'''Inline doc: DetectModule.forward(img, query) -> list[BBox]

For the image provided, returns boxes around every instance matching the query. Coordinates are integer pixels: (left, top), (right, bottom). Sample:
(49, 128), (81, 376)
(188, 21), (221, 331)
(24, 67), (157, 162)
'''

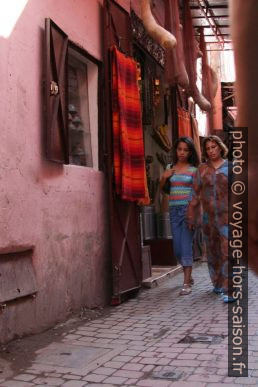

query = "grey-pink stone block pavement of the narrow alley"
(0, 263), (258, 387)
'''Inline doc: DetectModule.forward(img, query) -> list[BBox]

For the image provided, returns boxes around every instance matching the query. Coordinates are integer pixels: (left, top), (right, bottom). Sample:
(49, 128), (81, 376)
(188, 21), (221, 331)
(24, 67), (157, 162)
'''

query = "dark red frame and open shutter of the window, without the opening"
(43, 18), (105, 170)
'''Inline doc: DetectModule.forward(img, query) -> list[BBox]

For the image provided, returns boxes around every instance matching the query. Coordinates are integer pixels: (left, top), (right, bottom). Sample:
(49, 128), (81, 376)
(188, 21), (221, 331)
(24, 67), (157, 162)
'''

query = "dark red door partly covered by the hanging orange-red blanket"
(103, 0), (142, 305)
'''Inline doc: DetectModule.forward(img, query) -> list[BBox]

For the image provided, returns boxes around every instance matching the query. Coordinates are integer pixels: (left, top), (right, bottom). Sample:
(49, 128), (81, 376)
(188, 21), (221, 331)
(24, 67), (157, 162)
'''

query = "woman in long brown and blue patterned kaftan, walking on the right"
(187, 136), (234, 302)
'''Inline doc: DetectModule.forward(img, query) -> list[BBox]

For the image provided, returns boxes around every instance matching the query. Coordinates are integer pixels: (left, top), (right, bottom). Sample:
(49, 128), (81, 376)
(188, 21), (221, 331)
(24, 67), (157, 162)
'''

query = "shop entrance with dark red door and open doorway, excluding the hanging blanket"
(103, 0), (179, 304)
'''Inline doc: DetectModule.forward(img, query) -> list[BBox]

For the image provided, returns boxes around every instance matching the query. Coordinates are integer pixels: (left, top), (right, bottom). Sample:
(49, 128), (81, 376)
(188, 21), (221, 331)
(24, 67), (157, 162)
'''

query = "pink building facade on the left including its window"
(0, 0), (111, 342)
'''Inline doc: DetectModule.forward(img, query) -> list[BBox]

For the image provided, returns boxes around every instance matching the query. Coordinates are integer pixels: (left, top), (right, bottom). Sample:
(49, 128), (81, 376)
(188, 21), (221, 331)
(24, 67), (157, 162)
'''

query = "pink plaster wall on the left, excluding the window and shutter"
(0, 0), (111, 342)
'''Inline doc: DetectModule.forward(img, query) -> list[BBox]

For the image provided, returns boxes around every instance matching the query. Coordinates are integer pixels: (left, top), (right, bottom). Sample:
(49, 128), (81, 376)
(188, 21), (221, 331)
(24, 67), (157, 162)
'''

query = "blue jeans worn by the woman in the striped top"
(169, 205), (194, 266)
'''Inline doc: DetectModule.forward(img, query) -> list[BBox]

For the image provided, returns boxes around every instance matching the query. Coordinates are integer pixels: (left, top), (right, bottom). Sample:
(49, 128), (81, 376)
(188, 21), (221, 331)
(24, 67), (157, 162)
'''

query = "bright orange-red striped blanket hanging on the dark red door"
(111, 46), (150, 204)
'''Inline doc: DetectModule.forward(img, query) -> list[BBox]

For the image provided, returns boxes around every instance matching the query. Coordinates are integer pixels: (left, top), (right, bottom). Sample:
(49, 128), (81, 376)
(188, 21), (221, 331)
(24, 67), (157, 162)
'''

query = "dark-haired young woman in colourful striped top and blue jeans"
(160, 137), (199, 295)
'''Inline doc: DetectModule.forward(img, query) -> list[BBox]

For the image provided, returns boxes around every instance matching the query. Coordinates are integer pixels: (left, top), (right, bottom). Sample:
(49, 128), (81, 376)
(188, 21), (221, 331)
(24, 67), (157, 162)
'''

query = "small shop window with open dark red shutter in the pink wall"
(45, 19), (99, 167)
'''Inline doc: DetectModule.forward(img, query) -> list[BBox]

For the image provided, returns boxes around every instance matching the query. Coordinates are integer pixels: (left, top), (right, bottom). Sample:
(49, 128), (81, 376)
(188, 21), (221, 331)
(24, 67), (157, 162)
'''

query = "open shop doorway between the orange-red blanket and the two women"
(131, 31), (177, 281)
